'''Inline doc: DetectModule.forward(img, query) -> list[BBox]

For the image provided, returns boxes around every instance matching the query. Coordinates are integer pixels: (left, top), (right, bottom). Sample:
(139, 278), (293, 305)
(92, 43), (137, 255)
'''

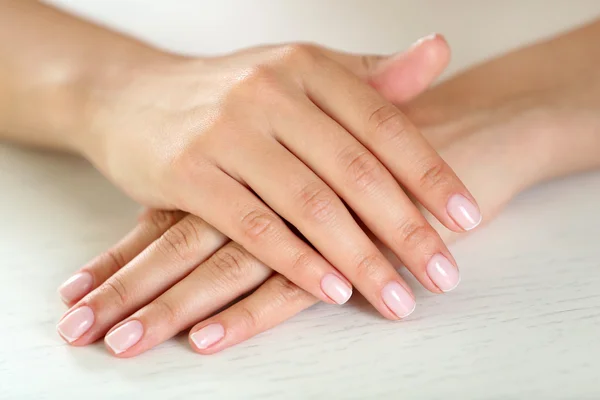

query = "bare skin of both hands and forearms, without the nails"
(0, 1), (598, 357)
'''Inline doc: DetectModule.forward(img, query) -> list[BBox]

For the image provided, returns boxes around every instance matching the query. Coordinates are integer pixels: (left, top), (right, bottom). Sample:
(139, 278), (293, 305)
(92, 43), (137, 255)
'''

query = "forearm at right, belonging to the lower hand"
(411, 21), (600, 185)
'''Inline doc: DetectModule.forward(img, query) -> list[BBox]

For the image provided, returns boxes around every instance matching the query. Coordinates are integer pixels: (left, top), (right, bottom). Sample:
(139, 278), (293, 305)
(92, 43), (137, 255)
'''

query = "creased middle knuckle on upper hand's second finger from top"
(342, 150), (384, 189)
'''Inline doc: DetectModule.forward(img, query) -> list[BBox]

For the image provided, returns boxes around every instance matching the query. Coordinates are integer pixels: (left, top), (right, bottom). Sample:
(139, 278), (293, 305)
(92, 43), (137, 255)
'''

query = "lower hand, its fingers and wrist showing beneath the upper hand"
(58, 87), (536, 357)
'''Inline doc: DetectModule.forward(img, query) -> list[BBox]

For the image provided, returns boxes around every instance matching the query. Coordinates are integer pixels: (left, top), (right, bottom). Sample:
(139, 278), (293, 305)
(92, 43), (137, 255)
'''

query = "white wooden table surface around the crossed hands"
(0, 0), (600, 400)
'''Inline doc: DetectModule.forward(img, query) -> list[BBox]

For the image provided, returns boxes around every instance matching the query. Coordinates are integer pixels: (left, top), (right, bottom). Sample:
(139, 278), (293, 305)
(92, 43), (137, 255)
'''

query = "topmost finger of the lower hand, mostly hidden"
(58, 210), (185, 307)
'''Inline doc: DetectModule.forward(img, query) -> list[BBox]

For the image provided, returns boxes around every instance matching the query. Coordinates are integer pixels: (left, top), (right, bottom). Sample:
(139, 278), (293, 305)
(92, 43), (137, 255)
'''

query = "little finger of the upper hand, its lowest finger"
(171, 162), (352, 304)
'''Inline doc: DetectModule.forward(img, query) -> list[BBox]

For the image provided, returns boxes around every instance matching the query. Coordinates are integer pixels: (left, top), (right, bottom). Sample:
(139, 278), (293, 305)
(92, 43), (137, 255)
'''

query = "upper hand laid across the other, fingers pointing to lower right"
(74, 37), (481, 319)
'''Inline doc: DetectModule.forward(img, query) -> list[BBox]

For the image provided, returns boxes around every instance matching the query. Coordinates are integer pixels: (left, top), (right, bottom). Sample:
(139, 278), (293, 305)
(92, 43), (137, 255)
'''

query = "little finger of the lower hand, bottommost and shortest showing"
(189, 274), (318, 354)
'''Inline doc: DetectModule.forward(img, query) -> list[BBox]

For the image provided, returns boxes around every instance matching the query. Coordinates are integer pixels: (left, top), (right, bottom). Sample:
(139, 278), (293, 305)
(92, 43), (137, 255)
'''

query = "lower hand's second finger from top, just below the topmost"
(57, 215), (228, 346)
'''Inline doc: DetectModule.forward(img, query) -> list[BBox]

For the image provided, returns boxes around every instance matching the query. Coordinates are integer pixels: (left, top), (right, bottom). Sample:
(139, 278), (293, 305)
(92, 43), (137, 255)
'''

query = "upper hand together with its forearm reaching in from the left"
(0, 1), (481, 319)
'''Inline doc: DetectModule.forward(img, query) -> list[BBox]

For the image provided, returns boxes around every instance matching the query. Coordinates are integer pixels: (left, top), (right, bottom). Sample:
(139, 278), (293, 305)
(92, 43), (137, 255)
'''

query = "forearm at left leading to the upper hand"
(0, 0), (164, 150)
